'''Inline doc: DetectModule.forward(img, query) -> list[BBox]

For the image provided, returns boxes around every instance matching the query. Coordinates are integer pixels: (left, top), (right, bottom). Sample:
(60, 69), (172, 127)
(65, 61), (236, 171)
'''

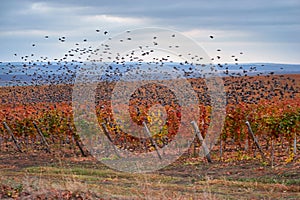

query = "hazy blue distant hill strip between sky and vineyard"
(0, 62), (300, 86)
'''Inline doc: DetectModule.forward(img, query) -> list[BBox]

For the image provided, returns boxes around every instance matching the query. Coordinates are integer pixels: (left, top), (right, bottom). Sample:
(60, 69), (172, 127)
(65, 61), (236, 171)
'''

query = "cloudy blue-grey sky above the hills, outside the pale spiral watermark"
(0, 0), (300, 64)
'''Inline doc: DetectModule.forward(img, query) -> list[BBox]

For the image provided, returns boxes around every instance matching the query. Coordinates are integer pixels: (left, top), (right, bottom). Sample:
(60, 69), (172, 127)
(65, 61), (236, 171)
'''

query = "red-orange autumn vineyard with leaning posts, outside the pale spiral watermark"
(0, 75), (300, 199)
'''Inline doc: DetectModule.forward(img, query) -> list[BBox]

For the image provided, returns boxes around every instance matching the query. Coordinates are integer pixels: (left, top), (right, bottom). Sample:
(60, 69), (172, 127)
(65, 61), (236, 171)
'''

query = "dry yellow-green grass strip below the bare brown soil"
(0, 160), (300, 199)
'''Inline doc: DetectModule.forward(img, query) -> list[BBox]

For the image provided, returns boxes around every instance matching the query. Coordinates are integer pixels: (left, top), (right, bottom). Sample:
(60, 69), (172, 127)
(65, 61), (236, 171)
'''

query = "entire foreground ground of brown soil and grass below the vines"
(0, 152), (300, 199)
